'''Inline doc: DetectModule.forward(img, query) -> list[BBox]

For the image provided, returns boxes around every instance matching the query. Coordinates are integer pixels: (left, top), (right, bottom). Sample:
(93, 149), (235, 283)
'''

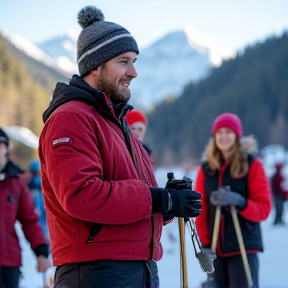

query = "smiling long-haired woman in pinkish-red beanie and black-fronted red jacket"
(195, 113), (271, 288)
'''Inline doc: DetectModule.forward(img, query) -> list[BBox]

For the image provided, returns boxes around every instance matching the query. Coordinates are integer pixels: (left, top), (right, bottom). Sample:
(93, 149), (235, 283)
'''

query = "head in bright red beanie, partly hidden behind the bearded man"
(125, 110), (147, 143)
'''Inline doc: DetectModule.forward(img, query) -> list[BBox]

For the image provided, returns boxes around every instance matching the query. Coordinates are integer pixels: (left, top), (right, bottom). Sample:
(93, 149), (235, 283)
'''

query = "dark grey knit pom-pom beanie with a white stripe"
(77, 6), (139, 77)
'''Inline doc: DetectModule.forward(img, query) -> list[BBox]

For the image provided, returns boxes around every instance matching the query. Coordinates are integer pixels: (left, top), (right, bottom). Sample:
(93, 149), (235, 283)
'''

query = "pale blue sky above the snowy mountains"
(0, 0), (288, 49)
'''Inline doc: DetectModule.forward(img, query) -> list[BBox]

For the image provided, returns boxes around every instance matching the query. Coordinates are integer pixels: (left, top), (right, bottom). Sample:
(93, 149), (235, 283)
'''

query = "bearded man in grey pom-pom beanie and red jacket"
(39, 6), (201, 288)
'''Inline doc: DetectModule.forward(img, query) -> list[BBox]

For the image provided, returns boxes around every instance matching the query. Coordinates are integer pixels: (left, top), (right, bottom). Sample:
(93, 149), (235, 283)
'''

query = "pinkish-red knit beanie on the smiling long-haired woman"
(212, 113), (242, 138)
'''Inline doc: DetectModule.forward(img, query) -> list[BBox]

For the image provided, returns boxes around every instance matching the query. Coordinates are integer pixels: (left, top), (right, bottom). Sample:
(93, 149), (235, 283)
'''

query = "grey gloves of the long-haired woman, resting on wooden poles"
(209, 189), (247, 209)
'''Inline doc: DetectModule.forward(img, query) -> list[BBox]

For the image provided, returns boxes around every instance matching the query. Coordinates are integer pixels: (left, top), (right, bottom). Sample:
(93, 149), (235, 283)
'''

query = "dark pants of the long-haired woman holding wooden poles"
(213, 254), (259, 288)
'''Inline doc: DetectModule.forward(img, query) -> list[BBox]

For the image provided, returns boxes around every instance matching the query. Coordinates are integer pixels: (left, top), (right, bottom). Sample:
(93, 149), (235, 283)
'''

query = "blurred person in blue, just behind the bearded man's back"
(28, 159), (49, 240)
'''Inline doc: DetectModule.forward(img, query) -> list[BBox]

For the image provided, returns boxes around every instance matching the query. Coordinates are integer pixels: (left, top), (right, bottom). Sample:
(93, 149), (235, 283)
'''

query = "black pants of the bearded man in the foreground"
(54, 260), (159, 288)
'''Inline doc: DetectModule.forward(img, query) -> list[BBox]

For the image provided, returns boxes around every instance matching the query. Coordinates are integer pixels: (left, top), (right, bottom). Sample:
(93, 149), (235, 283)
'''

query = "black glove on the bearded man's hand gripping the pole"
(150, 185), (202, 218)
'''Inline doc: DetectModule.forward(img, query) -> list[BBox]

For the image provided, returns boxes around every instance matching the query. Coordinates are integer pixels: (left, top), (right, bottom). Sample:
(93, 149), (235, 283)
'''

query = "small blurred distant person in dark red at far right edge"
(271, 162), (288, 225)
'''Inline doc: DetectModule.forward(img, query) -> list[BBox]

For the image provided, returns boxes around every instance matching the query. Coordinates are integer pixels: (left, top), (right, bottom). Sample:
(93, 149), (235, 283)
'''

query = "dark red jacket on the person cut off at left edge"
(0, 161), (48, 267)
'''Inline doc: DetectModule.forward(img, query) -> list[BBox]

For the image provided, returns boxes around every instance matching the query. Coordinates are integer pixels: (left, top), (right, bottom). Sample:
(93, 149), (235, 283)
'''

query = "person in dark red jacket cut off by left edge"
(0, 128), (50, 288)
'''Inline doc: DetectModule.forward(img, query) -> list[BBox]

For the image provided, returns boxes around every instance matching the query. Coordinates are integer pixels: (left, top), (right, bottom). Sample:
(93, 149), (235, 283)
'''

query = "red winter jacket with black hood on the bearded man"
(39, 75), (163, 265)
